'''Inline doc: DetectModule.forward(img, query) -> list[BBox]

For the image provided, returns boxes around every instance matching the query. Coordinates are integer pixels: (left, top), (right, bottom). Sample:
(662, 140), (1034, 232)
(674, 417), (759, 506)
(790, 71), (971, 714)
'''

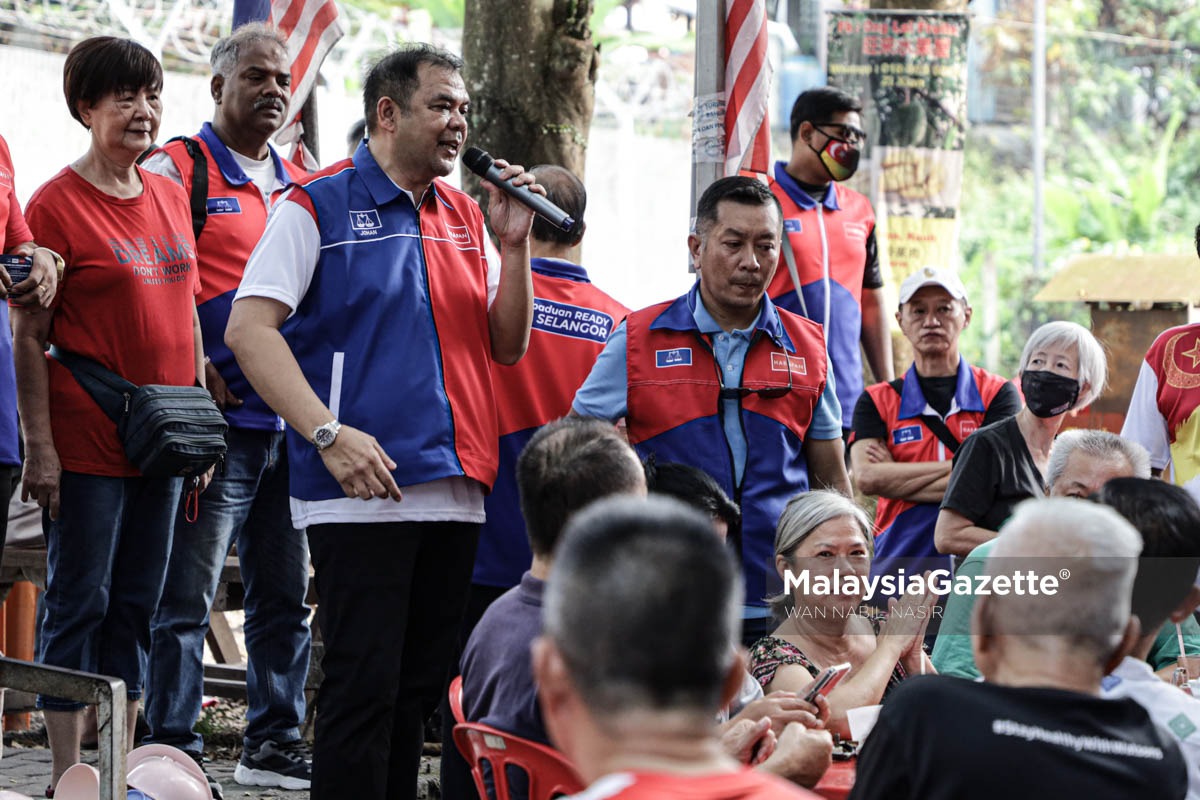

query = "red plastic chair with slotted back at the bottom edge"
(454, 722), (584, 800)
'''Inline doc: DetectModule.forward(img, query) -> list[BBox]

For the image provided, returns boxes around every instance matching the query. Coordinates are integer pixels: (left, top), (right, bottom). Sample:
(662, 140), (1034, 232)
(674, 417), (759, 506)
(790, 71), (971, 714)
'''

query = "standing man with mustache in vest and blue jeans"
(143, 23), (311, 800)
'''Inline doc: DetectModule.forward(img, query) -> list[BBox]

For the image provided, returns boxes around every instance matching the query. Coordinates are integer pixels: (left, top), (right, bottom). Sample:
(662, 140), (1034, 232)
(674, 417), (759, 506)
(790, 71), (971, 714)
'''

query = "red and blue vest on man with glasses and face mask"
(767, 162), (875, 428)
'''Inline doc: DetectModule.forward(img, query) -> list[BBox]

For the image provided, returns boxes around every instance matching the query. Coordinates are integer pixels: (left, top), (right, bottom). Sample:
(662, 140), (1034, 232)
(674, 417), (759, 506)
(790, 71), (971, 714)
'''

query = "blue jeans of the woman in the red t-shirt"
(37, 471), (184, 711)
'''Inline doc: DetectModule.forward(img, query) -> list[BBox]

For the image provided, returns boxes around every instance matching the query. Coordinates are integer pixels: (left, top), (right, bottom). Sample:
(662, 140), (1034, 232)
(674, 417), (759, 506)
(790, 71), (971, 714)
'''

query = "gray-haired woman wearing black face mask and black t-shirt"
(934, 321), (1108, 558)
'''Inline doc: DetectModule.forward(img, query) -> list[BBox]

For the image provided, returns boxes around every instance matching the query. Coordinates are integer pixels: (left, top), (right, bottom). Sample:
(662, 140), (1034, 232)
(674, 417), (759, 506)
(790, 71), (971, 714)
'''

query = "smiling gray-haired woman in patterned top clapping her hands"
(750, 492), (935, 736)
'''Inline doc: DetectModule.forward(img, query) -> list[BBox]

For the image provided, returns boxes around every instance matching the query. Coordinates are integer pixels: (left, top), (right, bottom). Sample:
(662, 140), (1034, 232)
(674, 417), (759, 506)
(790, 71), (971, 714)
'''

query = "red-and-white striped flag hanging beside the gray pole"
(725, 0), (772, 175)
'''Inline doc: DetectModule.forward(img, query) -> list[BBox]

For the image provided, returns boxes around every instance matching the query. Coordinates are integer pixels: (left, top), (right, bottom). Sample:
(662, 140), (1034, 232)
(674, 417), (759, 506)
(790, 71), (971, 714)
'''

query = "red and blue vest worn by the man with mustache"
(162, 122), (305, 431)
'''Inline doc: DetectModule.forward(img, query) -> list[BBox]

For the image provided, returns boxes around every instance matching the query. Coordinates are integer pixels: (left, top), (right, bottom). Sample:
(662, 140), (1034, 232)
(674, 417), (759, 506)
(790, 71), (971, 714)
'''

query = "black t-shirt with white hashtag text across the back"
(850, 675), (1188, 800)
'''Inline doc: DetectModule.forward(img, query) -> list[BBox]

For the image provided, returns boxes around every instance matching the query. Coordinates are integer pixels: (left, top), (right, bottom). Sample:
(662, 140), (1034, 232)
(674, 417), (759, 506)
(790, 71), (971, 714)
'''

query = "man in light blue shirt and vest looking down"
(571, 178), (850, 638)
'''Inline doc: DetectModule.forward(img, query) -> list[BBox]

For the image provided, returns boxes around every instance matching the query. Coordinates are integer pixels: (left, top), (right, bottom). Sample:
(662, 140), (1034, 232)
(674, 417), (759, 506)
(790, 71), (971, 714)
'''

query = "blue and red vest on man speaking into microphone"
(280, 144), (497, 500)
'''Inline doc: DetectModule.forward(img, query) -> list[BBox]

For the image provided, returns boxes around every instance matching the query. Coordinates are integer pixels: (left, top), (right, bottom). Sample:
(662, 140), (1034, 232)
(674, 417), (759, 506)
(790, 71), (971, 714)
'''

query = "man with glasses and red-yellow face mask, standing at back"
(768, 86), (894, 437)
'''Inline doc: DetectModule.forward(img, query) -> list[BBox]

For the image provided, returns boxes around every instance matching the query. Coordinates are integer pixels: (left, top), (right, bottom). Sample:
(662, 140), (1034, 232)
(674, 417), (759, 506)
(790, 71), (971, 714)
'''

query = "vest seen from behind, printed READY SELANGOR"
(472, 258), (629, 587)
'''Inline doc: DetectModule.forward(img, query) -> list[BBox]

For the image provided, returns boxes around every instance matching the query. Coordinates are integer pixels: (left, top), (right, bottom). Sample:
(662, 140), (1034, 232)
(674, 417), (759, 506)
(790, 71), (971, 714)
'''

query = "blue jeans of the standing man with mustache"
(145, 428), (311, 752)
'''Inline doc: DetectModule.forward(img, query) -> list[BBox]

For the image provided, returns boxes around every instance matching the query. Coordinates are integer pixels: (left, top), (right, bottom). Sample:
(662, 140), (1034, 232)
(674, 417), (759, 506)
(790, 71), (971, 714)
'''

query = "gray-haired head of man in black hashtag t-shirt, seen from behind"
(974, 498), (1141, 663)
